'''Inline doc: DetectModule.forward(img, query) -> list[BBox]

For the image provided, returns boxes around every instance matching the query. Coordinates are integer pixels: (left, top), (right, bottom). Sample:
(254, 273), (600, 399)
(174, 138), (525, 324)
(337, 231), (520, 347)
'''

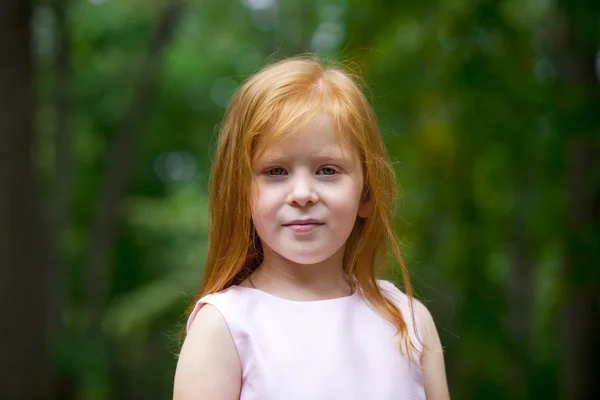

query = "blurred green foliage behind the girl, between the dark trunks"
(34, 0), (600, 399)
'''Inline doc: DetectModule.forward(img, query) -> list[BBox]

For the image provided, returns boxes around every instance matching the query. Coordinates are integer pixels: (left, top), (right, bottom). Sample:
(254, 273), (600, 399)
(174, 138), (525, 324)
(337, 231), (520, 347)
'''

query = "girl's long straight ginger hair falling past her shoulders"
(189, 57), (417, 355)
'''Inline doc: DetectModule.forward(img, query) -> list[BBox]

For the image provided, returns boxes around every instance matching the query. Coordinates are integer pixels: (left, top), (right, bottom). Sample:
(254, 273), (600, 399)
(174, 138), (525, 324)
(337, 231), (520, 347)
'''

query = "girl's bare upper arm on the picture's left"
(173, 304), (241, 400)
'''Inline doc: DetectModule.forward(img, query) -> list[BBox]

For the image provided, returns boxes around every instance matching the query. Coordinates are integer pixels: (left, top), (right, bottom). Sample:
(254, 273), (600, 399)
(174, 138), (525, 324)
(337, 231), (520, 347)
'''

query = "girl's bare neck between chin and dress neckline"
(251, 246), (352, 300)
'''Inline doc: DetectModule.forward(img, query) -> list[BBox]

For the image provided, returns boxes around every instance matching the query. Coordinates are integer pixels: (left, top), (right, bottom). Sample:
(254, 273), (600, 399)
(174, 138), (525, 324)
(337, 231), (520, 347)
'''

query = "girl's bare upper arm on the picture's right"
(414, 300), (450, 400)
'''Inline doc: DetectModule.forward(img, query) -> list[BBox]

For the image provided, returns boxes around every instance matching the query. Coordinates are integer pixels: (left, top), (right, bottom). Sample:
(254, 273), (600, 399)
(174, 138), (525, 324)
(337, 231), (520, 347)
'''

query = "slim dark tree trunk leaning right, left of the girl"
(84, 0), (183, 337)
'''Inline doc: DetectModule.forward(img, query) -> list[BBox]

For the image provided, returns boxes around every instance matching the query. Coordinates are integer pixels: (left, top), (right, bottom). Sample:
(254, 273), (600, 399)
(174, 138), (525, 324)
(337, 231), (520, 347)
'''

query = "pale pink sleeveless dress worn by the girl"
(187, 280), (425, 400)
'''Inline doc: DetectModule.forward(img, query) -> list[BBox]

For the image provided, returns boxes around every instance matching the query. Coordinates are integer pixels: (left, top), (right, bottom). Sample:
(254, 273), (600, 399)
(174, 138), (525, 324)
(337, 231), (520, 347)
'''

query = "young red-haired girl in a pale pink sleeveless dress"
(174, 54), (448, 400)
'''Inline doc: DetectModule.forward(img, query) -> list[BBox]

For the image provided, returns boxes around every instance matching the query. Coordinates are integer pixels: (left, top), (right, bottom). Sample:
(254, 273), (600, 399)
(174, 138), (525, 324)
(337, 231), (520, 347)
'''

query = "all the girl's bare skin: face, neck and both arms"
(174, 114), (449, 400)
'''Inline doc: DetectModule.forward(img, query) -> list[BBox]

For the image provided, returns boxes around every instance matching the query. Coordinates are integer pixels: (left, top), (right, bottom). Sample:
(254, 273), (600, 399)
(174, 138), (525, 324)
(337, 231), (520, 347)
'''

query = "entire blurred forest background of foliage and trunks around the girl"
(0, 0), (600, 400)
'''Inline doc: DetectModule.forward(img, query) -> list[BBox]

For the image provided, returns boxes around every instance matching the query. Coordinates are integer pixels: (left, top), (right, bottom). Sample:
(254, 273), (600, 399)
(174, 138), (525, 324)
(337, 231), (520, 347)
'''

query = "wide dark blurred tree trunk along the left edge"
(0, 0), (52, 399)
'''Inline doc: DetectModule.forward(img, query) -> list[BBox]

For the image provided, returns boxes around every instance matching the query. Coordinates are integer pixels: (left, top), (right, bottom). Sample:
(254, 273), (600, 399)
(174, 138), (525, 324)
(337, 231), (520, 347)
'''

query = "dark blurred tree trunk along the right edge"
(556, 1), (600, 400)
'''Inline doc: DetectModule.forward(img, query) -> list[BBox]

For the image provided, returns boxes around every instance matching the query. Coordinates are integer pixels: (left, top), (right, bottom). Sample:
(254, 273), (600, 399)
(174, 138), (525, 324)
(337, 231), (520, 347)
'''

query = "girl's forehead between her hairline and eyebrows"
(253, 114), (355, 161)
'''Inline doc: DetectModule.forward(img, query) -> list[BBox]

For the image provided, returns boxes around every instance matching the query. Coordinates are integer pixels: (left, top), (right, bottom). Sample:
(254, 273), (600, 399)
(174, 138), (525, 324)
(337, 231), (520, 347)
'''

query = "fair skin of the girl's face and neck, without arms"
(246, 114), (368, 300)
